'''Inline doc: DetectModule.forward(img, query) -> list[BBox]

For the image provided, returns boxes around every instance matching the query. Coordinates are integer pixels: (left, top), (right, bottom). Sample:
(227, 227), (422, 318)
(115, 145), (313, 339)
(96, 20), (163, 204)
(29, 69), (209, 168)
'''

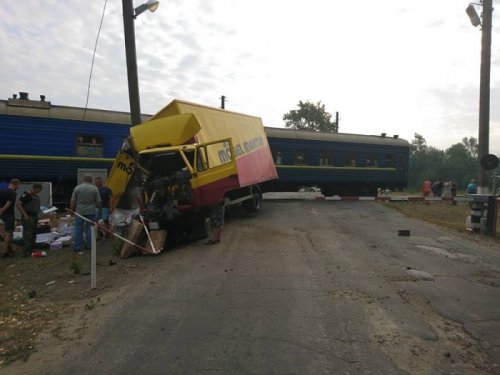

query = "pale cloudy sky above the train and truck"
(0, 0), (500, 156)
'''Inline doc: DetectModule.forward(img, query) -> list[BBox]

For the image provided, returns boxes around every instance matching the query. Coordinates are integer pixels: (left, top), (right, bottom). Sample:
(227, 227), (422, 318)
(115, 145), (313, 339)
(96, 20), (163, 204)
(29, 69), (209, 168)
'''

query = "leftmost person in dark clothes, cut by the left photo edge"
(0, 178), (21, 258)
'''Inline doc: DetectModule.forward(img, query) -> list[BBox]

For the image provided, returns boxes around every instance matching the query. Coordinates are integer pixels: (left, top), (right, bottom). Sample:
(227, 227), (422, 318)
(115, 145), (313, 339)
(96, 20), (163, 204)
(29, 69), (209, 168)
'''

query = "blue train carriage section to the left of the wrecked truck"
(0, 98), (139, 202)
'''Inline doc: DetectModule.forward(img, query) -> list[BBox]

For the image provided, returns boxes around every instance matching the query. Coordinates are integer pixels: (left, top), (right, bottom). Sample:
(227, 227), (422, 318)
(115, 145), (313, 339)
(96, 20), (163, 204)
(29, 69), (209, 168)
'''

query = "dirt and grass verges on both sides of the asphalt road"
(0, 202), (500, 367)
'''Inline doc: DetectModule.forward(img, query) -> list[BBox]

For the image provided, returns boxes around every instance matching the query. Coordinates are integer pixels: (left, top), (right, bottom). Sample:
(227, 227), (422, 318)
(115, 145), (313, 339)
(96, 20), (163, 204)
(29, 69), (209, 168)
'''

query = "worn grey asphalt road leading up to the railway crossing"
(11, 201), (500, 374)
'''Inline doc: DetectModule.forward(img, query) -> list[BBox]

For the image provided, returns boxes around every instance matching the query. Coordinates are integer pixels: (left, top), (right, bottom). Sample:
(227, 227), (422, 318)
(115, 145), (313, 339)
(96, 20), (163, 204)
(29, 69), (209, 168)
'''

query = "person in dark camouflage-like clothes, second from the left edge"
(16, 184), (42, 257)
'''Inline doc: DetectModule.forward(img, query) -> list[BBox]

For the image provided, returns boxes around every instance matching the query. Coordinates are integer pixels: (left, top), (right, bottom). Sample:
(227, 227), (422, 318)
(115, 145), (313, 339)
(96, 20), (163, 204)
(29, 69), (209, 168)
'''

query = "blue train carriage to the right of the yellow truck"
(266, 128), (409, 195)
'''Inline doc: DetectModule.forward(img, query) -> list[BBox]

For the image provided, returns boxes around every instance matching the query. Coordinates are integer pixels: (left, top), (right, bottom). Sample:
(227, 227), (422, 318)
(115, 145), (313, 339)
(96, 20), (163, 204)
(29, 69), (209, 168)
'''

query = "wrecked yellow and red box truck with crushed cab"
(108, 100), (277, 244)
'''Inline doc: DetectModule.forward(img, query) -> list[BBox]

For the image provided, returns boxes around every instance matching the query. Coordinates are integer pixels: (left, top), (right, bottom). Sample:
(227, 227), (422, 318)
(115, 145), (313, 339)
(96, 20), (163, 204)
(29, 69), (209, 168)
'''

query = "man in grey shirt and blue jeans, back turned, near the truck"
(69, 174), (102, 253)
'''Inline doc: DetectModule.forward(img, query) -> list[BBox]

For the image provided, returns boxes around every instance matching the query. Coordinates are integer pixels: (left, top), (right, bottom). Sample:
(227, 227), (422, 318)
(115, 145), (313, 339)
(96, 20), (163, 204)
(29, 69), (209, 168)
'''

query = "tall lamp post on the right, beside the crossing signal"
(466, 0), (493, 189)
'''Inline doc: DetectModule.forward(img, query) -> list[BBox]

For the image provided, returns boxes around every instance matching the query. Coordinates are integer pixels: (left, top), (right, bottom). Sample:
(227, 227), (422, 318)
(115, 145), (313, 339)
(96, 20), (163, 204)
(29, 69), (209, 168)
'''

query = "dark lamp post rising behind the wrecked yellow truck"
(122, 0), (160, 125)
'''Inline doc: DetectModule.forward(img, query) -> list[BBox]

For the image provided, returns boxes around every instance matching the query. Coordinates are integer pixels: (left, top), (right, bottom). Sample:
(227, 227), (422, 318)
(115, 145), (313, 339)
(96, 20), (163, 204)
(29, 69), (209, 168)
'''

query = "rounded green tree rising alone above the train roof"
(283, 101), (339, 133)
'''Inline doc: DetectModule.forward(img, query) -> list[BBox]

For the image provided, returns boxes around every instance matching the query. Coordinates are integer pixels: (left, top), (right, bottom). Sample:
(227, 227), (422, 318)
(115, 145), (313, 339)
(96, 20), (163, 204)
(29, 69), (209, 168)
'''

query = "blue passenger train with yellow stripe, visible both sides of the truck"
(0, 97), (409, 204)
